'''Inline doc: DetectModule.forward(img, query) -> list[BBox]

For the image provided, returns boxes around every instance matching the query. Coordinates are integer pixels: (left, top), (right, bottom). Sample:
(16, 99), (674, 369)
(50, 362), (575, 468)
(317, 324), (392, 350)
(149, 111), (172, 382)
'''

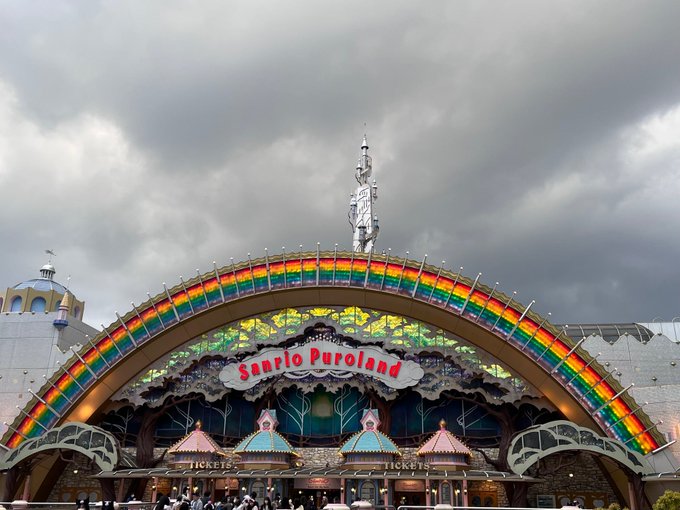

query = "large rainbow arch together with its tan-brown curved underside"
(3, 251), (663, 454)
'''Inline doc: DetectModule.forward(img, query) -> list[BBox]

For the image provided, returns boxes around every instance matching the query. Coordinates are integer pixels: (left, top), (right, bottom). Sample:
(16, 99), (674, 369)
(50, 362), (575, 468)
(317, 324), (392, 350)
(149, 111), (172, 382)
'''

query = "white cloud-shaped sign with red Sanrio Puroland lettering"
(219, 340), (424, 390)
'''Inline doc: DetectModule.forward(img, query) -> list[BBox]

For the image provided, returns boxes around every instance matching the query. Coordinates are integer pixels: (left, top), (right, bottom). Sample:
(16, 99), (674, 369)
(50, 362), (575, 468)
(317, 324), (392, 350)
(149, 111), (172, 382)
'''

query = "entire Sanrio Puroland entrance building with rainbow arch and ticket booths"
(0, 143), (680, 509)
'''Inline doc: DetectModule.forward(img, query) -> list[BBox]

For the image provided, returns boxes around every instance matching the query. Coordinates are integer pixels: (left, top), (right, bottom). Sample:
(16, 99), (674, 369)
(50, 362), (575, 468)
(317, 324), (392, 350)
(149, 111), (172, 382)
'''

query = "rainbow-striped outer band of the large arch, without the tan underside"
(3, 251), (663, 454)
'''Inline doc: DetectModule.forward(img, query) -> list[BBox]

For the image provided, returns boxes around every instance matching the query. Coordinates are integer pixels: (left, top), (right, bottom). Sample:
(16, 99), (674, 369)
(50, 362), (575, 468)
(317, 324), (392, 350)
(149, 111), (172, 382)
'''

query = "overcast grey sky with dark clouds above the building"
(0, 0), (680, 327)
